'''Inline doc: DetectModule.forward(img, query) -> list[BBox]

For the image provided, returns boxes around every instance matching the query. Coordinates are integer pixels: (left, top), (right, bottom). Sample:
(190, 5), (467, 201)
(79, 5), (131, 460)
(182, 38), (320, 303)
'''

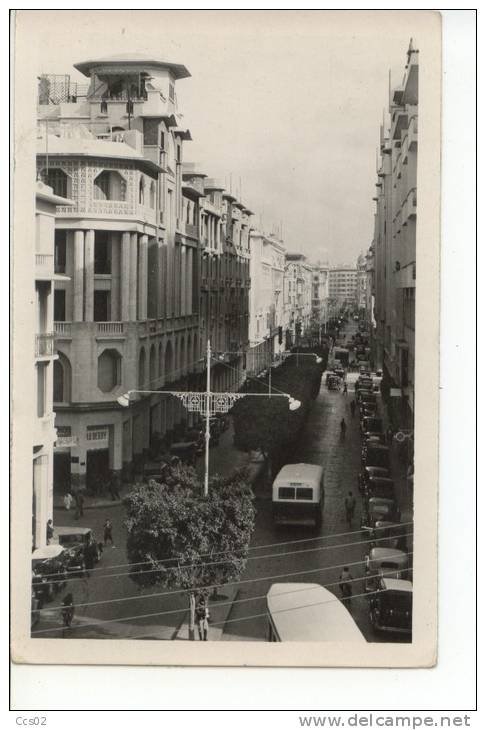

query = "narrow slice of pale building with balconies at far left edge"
(32, 181), (70, 549)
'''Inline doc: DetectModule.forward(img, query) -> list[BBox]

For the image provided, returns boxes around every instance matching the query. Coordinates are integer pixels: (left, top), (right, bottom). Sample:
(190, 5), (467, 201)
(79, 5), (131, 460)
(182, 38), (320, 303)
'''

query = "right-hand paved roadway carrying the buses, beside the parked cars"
(223, 323), (412, 641)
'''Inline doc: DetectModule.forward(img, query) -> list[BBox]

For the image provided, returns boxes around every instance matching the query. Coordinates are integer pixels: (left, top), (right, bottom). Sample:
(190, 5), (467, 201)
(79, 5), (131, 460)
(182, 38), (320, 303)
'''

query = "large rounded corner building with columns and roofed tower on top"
(38, 55), (204, 489)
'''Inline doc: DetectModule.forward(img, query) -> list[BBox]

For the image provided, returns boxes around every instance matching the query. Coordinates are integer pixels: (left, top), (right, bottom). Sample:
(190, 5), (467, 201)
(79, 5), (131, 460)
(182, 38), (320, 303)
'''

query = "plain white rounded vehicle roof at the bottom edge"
(267, 583), (366, 644)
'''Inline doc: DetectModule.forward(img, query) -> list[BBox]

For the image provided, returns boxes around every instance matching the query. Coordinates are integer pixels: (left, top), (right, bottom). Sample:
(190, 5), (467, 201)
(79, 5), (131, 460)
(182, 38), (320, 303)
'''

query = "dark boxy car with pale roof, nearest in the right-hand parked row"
(370, 578), (413, 634)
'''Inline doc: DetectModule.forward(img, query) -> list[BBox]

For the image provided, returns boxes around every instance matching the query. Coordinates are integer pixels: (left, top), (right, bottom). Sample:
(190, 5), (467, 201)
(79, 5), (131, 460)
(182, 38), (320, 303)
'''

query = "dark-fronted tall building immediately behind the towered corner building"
(196, 173), (252, 391)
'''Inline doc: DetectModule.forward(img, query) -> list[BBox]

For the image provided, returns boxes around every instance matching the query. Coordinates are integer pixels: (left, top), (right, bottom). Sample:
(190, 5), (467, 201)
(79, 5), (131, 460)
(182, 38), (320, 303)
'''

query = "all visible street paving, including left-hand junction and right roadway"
(34, 323), (411, 641)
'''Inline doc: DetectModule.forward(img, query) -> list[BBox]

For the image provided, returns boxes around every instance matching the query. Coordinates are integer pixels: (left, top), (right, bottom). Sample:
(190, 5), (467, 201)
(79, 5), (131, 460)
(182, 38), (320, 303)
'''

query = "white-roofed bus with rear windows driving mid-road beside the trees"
(272, 464), (324, 528)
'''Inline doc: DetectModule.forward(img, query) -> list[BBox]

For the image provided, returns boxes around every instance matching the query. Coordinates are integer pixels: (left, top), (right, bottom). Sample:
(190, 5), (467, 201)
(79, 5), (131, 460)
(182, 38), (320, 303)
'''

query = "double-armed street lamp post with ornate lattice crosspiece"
(117, 340), (301, 497)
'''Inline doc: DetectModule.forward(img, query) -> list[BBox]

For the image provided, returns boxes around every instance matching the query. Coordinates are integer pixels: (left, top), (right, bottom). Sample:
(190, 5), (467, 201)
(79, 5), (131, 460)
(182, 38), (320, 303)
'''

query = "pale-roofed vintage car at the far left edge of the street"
(32, 544), (69, 608)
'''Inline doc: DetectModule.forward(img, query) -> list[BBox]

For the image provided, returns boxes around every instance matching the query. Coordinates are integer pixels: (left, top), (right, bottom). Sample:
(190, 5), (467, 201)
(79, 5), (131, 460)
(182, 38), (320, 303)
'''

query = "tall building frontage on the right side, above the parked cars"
(373, 42), (419, 426)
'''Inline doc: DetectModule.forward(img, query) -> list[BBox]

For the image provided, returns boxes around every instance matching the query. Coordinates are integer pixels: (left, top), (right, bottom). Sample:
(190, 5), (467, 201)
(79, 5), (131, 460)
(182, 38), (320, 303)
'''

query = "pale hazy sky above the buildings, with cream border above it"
(24, 10), (428, 263)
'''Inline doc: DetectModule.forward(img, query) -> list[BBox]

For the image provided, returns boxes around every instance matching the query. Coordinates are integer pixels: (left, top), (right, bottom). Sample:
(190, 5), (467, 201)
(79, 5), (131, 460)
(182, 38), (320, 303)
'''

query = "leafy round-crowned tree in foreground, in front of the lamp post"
(124, 466), (255, 639)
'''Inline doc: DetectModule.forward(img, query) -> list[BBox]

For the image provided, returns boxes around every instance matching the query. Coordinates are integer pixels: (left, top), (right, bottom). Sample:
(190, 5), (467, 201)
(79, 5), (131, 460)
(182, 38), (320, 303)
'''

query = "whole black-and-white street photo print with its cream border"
(12, 10), (440, 666)
